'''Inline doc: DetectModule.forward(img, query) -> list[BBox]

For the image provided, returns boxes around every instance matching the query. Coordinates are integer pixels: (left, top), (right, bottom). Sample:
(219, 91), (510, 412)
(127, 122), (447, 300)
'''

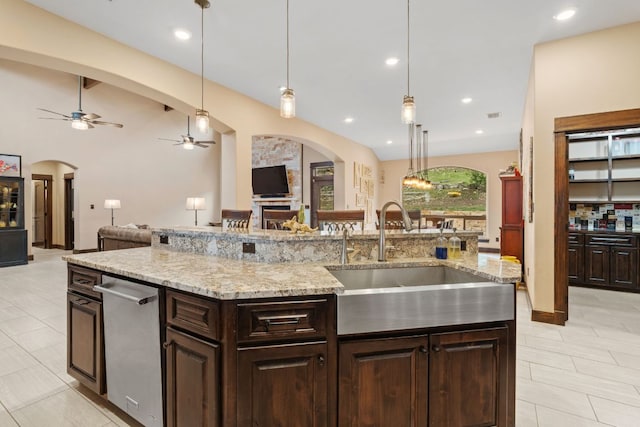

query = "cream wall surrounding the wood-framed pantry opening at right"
(526, 22), (640, 312)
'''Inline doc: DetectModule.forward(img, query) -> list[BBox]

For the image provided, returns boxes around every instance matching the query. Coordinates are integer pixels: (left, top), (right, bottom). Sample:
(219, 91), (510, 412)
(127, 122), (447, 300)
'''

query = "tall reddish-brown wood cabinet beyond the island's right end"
(500, 176), (524, 263)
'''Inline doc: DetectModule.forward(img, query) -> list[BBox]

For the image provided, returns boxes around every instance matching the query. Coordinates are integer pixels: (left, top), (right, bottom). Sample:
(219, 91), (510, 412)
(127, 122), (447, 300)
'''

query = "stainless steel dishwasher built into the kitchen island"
(94, 275), (163, 427)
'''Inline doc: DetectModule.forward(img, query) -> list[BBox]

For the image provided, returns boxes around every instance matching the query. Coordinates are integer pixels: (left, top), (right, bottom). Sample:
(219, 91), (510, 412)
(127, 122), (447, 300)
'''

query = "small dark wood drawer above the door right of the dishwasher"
(167, 290), (220, 340)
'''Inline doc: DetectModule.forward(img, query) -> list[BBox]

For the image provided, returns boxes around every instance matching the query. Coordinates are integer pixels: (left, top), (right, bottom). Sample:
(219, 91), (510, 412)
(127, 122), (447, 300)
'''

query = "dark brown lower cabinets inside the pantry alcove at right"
(568, 233), (640, 291)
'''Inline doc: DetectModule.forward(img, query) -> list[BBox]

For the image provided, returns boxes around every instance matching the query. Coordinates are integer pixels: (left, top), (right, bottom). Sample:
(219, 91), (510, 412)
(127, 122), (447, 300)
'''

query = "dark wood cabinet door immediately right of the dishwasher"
(164, 328), (220, 427)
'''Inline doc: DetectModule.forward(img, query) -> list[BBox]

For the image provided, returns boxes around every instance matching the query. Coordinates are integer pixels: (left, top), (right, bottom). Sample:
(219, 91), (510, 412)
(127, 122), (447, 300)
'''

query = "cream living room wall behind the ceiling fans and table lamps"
(0, 60), (220, 250)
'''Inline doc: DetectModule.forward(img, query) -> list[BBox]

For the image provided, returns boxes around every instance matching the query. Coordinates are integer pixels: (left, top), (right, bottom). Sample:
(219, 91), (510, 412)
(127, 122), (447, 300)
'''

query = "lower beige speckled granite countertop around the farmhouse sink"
(62, 247), (521, 300)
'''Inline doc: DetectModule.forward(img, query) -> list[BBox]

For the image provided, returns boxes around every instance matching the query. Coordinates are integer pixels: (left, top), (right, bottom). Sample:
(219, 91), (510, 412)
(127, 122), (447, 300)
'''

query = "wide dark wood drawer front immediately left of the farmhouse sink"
(238, 299), (329, 343)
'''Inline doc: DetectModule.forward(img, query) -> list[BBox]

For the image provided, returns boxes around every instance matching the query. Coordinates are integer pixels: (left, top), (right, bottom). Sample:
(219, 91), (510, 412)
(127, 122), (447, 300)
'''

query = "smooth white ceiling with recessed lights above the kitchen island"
(26, 0), (640, 160)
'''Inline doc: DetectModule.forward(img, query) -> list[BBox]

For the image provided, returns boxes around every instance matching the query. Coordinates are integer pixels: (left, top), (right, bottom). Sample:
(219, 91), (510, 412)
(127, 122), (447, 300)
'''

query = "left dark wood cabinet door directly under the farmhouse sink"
(338, 336), (429, 427)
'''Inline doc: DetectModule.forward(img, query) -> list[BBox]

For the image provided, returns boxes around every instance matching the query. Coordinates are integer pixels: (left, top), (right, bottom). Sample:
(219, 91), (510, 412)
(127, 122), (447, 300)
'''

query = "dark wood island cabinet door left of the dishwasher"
(67, 292), (106, 394)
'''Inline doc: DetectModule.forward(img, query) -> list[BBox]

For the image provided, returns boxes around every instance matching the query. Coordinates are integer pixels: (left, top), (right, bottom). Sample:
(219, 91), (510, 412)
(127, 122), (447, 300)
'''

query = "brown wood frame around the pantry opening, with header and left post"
(552, 108), (640, 325)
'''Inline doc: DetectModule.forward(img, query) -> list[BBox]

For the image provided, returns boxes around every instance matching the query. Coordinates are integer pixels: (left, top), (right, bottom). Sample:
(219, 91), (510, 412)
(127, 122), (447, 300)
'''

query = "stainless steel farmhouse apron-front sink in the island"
(329, 266), (515, 335)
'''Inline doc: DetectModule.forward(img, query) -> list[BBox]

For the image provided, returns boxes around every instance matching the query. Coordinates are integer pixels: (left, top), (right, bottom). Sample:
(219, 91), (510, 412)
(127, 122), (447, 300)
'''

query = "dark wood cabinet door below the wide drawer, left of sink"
(237, 341), (329, 427)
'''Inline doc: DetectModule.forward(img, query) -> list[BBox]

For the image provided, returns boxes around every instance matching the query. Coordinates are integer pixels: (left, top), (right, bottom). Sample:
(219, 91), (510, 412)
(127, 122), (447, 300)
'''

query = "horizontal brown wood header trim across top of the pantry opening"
(554, 108), (640, 133)
